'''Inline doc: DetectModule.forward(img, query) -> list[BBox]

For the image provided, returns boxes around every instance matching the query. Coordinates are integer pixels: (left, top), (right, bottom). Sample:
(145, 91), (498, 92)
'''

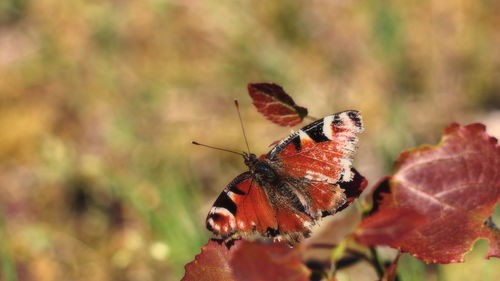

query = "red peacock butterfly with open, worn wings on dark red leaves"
(206, 110), (366, 245)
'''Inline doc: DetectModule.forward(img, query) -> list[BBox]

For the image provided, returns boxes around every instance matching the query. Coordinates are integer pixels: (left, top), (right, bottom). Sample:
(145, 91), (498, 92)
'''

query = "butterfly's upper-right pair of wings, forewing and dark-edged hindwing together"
(261, 110), (366, 219)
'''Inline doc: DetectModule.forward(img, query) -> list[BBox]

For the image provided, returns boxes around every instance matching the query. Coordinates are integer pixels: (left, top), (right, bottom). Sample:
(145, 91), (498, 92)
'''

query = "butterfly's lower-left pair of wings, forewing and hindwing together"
(207, 172), (314, 243)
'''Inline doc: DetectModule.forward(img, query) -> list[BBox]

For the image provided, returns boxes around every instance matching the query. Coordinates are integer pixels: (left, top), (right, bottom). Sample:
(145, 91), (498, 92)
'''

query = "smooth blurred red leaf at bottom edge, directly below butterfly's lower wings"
(231, 241), (311, 281)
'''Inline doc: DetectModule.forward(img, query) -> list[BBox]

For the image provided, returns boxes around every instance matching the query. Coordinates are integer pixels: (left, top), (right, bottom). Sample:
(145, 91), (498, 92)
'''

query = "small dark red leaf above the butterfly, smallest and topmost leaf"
(247, 83), (307, 126)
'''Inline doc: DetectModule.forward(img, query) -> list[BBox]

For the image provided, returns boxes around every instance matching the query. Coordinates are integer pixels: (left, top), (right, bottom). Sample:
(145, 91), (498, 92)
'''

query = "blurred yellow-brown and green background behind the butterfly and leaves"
(0, 0), (500, 281)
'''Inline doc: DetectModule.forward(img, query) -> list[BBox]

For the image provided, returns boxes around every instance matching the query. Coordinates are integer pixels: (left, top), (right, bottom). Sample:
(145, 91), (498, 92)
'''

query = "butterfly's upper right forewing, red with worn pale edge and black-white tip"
(266, 110), (363, 184)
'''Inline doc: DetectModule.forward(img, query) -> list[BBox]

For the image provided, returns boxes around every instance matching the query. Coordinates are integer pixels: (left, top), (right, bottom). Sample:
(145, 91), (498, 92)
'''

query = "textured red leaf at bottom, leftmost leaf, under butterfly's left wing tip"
(181, 240), (240, 281)
